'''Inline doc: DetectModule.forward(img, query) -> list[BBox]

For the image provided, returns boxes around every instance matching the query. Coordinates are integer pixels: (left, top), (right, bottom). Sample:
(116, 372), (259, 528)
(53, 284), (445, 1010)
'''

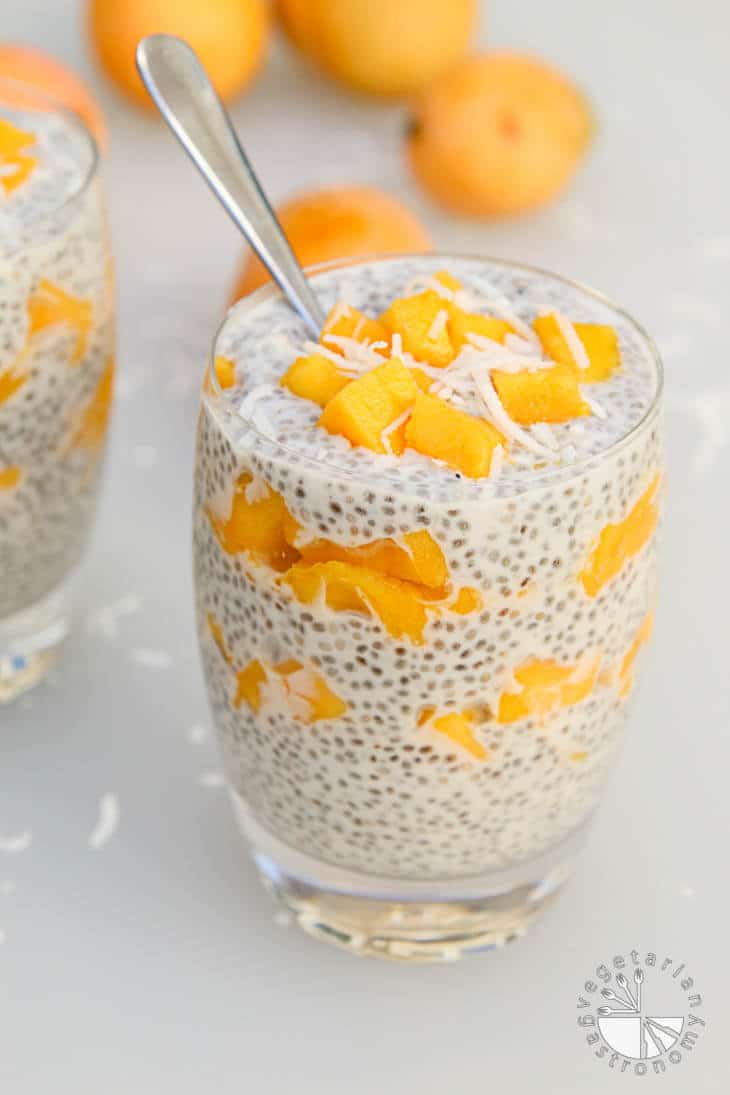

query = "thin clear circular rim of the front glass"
(201, 250), (664, 498)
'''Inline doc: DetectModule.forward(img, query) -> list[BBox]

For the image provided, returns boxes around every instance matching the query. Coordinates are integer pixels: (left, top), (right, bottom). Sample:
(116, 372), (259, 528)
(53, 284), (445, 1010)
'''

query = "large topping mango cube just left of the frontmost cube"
(318, 358), (418, 452)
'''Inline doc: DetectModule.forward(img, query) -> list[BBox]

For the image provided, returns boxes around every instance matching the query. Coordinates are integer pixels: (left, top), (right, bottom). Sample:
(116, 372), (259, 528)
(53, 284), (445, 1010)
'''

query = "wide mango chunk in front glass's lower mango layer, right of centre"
(497, 657), (601, 723)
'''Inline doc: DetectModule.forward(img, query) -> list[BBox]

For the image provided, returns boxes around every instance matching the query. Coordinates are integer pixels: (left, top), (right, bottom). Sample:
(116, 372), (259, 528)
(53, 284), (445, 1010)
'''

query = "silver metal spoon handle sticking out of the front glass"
(137, 34), (324, 338)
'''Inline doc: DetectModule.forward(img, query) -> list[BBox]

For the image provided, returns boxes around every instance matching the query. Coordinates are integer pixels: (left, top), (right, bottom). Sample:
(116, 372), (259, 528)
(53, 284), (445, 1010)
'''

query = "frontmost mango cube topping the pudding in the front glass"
(405, 392), (502, 479)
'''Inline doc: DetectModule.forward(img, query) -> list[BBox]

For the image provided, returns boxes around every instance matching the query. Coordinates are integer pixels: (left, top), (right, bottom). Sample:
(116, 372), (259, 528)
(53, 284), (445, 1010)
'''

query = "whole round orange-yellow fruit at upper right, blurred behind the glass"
(407, 54), (592, 218)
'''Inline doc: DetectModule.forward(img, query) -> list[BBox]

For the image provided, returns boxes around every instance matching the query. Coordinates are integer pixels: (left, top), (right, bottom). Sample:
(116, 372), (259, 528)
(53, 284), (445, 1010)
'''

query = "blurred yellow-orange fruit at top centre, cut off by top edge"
(278, 0), (477, 96)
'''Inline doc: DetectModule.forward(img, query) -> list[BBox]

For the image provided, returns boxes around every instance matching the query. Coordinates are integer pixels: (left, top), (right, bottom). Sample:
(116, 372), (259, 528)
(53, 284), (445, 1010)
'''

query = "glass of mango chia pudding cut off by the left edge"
(0, 80), (115, 701)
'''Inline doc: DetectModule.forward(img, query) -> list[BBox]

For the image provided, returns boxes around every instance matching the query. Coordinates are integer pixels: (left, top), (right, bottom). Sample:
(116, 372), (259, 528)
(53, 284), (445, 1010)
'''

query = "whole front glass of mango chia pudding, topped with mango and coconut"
(194, 255), (662, 959)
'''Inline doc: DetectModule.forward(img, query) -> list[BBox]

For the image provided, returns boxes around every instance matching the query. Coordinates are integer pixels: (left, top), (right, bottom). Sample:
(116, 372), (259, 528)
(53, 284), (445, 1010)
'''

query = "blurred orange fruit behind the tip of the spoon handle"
(89, 0), (270, 110)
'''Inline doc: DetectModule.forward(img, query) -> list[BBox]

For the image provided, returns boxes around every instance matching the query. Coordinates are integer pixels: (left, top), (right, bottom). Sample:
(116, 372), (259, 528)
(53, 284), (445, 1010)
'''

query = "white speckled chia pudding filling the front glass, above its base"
(194, 255), (662, 880)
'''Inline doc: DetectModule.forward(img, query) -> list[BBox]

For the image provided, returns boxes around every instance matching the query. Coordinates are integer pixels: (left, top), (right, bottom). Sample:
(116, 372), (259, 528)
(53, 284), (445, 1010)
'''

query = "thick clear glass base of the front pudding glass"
(231, 791), (587, 961)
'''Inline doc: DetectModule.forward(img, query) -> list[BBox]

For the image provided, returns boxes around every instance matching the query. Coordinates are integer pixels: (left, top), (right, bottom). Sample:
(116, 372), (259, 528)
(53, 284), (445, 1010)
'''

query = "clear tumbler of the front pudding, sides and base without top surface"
(194, 255), (662, 960)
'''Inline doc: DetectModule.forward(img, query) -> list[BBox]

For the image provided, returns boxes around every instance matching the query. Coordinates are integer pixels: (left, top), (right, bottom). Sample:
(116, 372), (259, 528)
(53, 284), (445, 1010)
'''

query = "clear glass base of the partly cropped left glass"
(0, 579), (71, 703)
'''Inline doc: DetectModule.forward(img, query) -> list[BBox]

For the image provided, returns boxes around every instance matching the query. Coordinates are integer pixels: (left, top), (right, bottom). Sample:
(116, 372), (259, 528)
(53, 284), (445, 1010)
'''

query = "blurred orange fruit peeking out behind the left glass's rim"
(0, 44), (106, 148)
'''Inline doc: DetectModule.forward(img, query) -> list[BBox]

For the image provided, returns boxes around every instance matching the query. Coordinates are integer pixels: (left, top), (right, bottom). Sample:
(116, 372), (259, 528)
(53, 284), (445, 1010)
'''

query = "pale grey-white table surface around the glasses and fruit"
(0, 0), (730, 1095)
